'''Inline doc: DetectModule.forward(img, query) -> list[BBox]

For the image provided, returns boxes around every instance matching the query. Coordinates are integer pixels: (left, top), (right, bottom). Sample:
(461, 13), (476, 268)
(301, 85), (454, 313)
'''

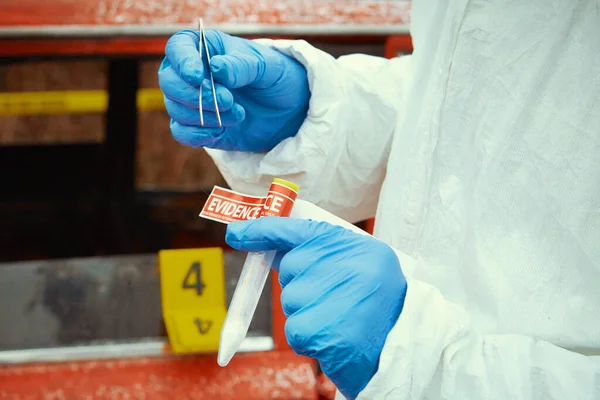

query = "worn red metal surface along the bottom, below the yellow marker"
(0, 351), (318, 400)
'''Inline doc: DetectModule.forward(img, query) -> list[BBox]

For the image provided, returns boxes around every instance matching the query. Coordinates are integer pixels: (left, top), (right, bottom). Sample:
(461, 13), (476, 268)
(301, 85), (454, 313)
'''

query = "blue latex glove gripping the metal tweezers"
(158, 30), (310, 152)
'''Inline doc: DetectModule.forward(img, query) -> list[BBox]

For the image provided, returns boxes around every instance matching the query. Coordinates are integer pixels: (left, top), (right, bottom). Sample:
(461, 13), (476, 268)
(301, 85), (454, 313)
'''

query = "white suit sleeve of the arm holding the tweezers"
(207, 40), (411, 222)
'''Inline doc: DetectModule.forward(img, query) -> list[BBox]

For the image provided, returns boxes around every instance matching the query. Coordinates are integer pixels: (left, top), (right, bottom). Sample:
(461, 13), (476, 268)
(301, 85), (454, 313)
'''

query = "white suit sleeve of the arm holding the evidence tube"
(359, 279), (600, 400)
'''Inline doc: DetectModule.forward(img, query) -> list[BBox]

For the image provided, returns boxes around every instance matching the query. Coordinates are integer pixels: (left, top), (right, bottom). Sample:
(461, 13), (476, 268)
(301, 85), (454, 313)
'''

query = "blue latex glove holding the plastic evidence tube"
(226, 217), (407, 399)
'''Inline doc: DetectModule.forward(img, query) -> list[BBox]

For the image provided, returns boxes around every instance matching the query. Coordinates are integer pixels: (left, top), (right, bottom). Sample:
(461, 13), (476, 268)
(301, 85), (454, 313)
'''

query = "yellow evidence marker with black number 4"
(158, 247), (227, 354)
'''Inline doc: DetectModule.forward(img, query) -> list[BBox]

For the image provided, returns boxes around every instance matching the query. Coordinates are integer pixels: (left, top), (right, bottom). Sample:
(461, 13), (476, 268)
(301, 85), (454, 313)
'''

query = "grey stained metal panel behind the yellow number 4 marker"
(0, 251), (271, 351)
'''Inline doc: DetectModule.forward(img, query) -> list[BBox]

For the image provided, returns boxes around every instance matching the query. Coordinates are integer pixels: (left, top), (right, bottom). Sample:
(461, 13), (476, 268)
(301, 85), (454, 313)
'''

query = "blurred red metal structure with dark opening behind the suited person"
(0, 0), (412, 399)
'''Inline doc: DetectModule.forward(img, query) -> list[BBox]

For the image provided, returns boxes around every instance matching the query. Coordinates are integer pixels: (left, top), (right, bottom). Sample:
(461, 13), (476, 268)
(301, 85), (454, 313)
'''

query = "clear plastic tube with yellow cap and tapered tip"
(217, 178), (298, 367)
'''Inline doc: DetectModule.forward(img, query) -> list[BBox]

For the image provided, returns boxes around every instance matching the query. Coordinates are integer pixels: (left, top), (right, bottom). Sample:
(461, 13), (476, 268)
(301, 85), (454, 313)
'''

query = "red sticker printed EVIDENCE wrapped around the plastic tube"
(200, 182), (298, 224)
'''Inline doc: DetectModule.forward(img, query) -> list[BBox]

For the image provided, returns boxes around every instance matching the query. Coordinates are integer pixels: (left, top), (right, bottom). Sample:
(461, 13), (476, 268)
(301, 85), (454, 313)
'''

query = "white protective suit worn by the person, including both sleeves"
(209, 0), (600, 400)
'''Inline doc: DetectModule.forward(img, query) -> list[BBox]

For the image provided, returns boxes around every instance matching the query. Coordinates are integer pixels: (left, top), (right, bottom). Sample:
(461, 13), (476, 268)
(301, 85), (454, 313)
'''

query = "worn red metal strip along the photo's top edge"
(0, 0), (410, 26)
